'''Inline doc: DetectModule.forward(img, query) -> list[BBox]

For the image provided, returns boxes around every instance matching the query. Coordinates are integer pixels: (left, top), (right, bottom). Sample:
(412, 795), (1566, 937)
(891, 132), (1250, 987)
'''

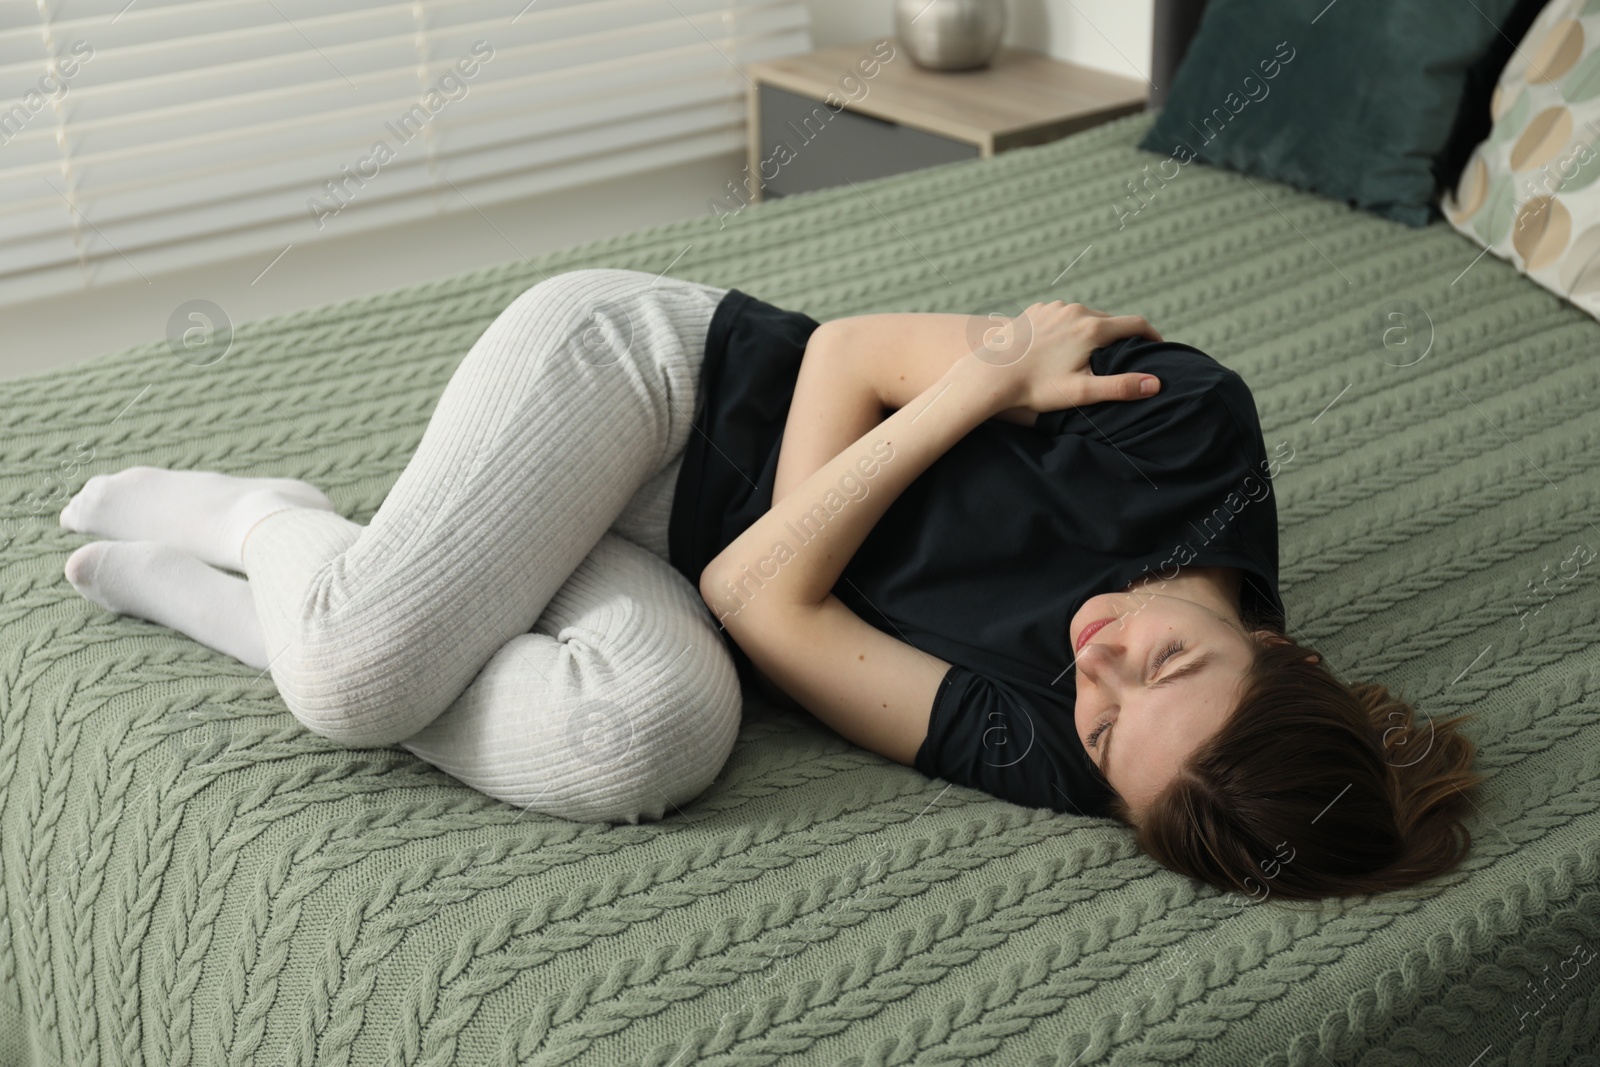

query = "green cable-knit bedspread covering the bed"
(0, 115), (1600, 1067)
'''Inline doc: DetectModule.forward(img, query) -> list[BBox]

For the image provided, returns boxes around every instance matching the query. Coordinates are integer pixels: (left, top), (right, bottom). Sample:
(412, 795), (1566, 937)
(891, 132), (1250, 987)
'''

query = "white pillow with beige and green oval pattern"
(1440, 0), (1600, 308)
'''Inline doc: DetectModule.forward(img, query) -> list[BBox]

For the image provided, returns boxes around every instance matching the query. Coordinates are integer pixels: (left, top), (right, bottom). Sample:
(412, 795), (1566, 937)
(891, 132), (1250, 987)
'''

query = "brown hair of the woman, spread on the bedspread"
(1110, 630), (1483, 901)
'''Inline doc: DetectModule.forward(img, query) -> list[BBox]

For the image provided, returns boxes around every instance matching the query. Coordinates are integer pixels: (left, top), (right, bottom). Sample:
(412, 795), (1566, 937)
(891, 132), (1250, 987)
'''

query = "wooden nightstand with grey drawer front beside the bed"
(742, 38), (1149, 200)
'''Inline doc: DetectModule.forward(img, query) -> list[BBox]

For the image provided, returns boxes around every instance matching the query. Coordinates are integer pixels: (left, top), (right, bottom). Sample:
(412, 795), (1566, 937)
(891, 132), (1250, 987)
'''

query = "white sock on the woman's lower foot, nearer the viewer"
(66, 541), (267, 670)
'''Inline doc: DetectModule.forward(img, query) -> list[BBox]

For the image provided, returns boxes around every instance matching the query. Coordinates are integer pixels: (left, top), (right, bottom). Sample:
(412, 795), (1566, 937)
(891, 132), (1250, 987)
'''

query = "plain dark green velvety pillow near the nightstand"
(1139, 0), (1541, 226)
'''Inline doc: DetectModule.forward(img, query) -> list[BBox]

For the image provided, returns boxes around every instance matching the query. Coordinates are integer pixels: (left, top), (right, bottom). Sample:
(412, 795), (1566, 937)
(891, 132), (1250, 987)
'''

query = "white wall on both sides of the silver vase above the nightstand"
(810, 0), (1154, 78)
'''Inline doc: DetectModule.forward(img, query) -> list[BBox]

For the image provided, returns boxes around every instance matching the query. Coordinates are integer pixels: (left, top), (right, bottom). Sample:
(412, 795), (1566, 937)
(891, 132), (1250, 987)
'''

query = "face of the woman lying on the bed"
(1070, 589), (1254, 813)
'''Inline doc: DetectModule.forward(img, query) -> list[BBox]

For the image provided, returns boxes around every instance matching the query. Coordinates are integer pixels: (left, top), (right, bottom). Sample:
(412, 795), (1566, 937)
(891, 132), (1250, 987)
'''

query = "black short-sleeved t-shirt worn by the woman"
(669, 290), (1285, 816)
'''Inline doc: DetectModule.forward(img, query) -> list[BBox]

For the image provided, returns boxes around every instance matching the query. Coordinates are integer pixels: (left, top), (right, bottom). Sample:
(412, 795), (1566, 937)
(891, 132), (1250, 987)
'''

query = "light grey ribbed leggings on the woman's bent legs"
(245, 270), (742, 822)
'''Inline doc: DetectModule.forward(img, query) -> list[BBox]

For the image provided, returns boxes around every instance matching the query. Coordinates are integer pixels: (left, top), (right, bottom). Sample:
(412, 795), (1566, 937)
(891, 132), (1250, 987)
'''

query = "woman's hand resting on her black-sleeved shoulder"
(973, 301), (1162, 414)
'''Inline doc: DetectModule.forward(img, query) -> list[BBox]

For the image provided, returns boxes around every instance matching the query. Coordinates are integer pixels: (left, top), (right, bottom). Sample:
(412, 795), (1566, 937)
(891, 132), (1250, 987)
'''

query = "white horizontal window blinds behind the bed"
(0, 0), (811, 302)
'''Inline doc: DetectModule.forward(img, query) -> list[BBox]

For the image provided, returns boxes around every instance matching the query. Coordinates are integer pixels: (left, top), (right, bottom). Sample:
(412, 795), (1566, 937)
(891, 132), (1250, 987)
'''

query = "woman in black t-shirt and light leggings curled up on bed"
(61, 270), (1477, 897)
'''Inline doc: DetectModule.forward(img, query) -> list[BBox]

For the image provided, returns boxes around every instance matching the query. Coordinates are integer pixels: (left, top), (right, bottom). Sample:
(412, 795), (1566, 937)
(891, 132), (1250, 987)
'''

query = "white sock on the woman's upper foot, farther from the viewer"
(61, 467), (333, 571)
